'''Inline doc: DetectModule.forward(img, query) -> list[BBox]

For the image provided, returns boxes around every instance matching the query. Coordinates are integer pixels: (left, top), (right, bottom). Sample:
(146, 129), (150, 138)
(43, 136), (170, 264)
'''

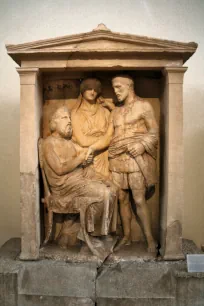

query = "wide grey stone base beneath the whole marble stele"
(0, 239), (204, 306)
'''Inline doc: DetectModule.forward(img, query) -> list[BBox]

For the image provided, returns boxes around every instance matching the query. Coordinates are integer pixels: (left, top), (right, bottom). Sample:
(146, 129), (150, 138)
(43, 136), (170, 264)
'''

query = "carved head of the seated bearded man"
(50, 106), (72, 138)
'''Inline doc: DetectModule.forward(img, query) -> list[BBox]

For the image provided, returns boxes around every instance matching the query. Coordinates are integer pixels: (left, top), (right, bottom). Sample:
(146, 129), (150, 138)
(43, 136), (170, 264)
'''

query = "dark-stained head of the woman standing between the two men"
(80, 78), (101, 103)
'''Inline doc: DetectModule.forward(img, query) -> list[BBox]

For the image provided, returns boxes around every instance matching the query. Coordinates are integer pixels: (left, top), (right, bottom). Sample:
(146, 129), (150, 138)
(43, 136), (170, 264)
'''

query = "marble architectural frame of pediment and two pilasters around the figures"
(6, 24), (197, 260)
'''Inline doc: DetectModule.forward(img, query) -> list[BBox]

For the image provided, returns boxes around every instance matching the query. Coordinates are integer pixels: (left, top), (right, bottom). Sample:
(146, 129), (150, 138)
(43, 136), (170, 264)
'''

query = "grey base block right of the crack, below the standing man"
(96, 262), (176, 299)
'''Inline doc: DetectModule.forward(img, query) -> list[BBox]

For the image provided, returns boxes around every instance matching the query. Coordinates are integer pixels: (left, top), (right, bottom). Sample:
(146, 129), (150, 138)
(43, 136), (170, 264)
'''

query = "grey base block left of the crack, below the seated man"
(18, 260), (97, 299)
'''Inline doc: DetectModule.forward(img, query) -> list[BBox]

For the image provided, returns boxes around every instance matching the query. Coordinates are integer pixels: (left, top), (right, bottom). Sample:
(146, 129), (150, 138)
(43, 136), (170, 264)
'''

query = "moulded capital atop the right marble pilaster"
(162, 67), (188, 84)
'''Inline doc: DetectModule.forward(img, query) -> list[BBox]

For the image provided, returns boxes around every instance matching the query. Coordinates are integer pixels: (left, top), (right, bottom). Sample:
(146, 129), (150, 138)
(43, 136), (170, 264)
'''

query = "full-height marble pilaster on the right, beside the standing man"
(161, 67), (187, 260)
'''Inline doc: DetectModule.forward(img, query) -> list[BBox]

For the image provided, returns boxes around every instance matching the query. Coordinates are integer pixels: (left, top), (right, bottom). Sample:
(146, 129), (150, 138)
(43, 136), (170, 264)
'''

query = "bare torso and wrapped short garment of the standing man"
(109, 100), (158, 190)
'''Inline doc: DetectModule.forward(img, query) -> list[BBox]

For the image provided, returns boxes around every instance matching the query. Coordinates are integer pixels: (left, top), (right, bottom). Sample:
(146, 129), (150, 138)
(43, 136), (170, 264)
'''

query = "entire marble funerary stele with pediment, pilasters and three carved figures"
(7, 24), (197, 261)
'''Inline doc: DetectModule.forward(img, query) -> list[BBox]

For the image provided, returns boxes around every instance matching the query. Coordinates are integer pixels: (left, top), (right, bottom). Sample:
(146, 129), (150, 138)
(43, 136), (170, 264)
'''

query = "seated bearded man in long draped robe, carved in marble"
(43, 107), (117, 260)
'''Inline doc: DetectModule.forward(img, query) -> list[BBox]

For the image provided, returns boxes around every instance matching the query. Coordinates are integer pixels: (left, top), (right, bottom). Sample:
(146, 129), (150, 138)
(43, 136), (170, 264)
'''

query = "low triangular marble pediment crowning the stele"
(7, 25), (197, 64)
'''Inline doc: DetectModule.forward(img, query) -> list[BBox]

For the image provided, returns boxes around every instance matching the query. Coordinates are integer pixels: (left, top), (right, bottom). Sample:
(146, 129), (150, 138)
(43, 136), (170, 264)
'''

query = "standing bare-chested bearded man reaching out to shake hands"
(89, 76), (158, 252)
